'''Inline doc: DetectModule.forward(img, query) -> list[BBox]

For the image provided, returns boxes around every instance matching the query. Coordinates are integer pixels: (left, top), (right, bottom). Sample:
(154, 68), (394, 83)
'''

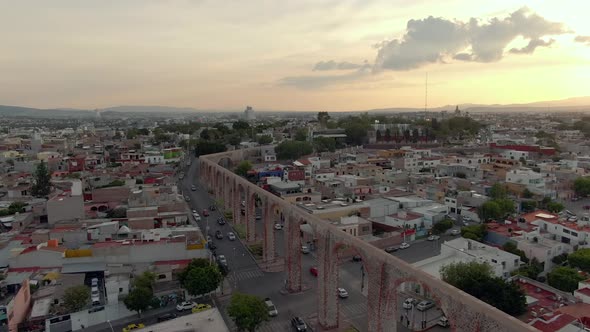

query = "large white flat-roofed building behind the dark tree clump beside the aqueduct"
(413, 238), (521, 279)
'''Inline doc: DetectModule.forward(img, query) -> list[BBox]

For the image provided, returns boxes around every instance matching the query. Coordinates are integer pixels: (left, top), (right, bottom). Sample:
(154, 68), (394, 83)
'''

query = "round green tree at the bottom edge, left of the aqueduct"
(227, 293), (269, 332)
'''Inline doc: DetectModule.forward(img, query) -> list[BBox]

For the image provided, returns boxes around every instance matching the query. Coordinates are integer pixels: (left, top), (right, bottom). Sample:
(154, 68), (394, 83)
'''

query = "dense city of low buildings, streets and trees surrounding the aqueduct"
(0, 107), (590, 331)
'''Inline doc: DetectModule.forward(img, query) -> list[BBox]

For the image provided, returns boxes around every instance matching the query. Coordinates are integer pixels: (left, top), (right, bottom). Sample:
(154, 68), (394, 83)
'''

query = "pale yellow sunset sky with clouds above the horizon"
(0, 0), (590, 111)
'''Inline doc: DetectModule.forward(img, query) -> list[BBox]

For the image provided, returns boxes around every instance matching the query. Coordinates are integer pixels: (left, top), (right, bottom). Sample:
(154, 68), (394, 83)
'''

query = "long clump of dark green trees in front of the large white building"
(440, 262), (526, 316)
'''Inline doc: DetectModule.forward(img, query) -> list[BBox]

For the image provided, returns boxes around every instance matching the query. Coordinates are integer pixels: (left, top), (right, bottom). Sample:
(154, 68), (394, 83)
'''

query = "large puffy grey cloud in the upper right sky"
(374, 8), (569, 71)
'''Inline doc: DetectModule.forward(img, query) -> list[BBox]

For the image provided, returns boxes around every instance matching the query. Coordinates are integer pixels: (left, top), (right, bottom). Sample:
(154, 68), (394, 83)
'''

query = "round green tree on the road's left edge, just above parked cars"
(179, 259), (223, 296)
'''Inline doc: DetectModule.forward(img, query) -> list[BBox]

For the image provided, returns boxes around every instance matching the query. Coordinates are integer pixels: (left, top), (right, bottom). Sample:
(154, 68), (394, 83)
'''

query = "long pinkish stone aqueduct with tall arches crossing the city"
(199, 149), (537, 332)
